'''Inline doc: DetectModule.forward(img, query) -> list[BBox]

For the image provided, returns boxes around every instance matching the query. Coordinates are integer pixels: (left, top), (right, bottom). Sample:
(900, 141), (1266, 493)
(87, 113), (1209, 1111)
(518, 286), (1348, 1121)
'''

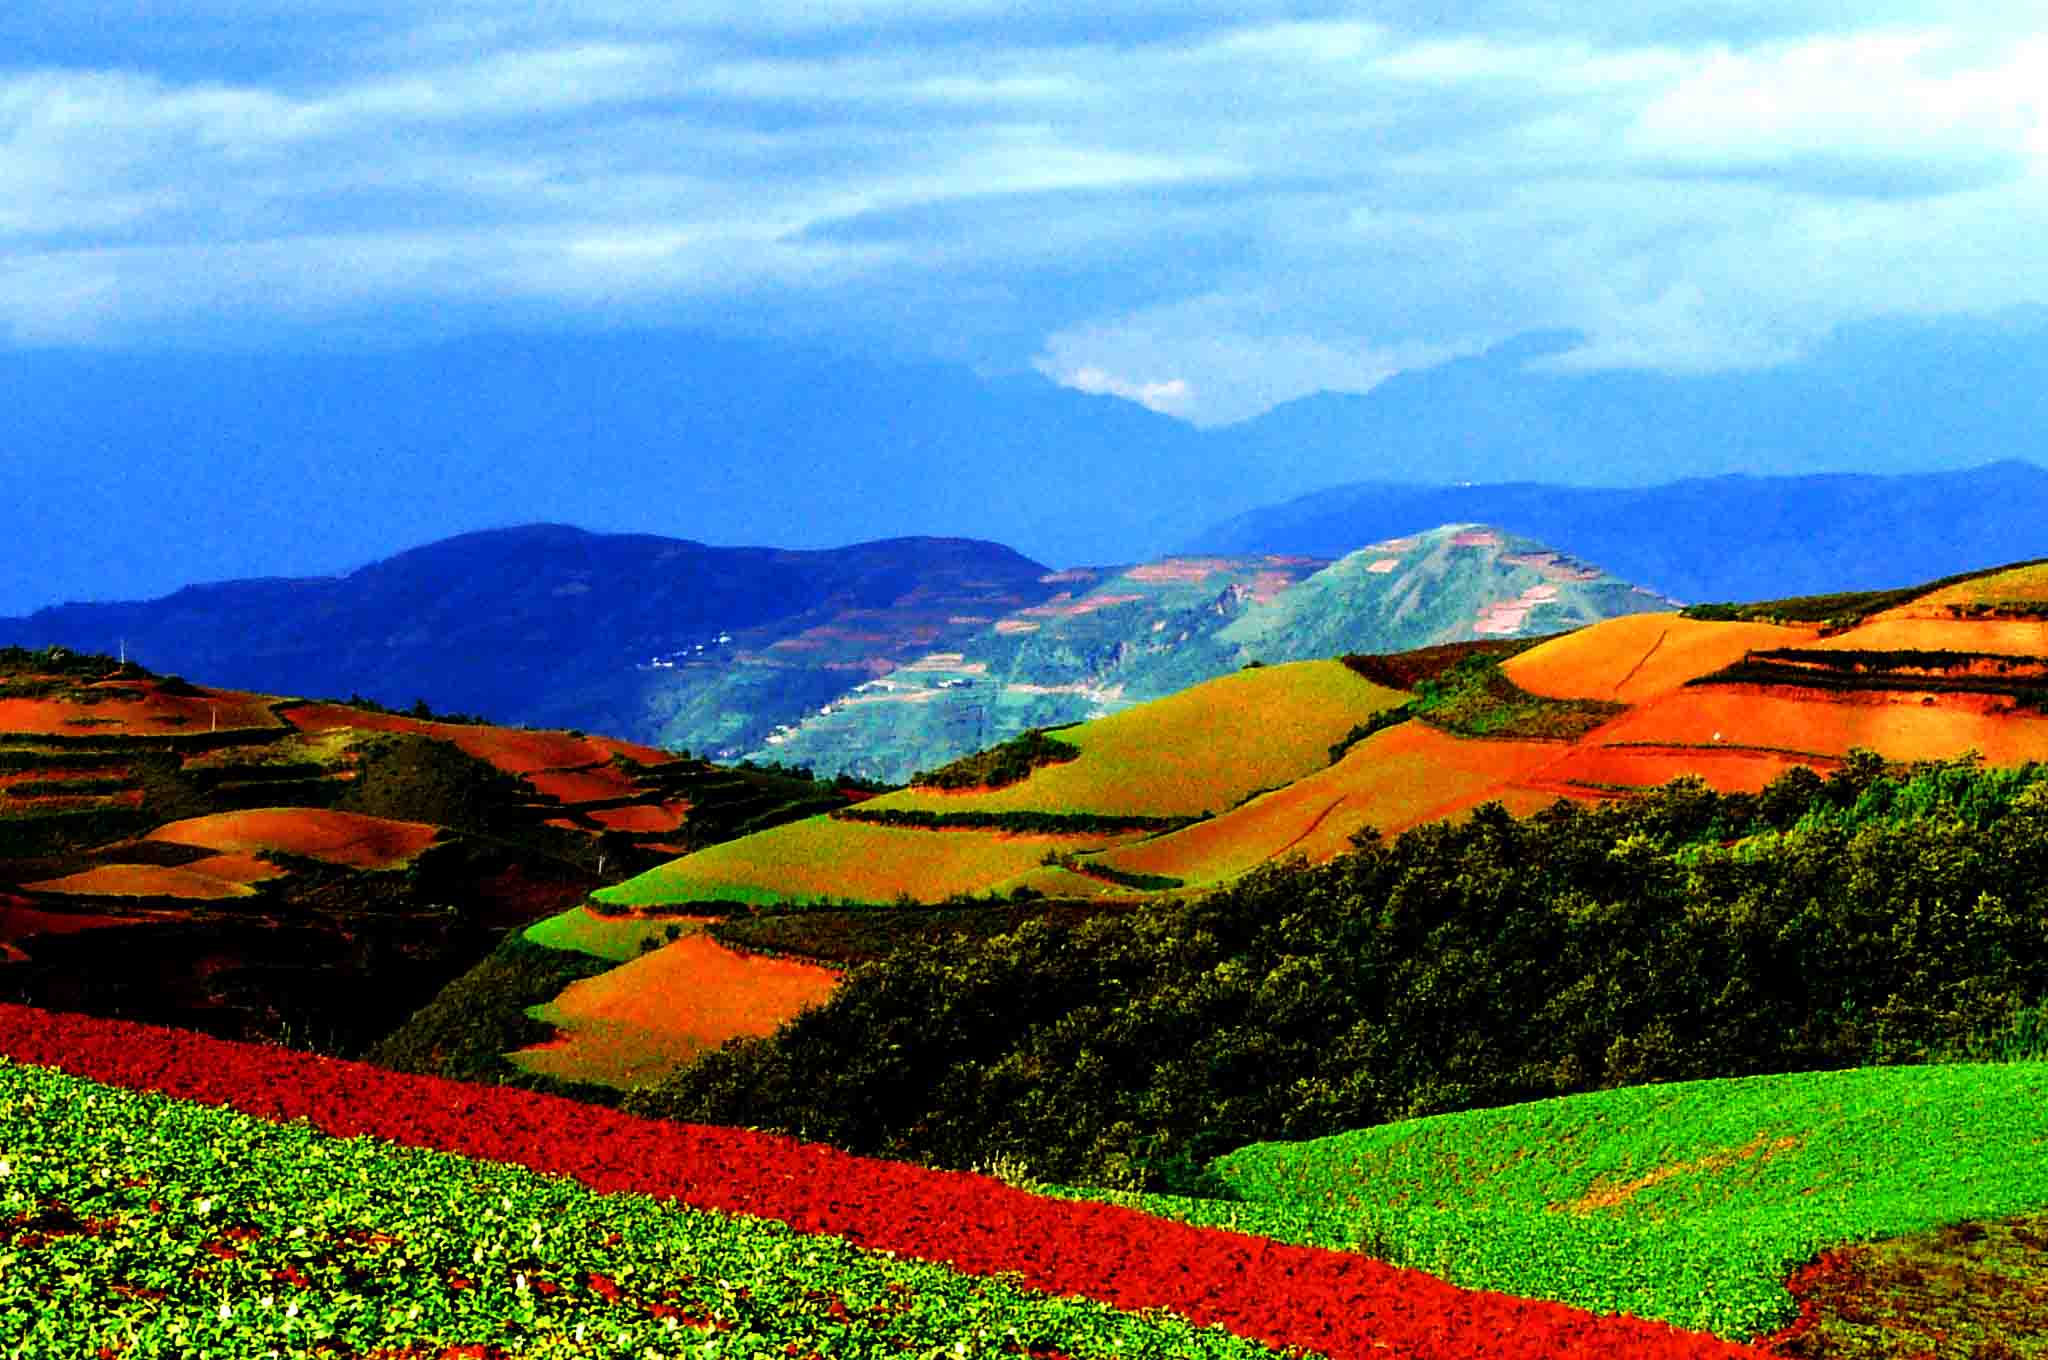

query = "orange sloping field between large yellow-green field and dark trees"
(1096, 723), (1569, 885)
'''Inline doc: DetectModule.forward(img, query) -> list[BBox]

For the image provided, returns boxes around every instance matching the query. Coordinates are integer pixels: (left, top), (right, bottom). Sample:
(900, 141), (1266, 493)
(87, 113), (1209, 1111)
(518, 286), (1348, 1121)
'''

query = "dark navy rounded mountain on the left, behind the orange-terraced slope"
(0, 524), (1053, 748)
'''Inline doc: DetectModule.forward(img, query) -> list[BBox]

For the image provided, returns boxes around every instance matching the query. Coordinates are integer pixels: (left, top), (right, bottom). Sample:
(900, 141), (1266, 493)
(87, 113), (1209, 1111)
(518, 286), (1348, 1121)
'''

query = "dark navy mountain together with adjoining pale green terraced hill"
(0, 524), (1667, 780)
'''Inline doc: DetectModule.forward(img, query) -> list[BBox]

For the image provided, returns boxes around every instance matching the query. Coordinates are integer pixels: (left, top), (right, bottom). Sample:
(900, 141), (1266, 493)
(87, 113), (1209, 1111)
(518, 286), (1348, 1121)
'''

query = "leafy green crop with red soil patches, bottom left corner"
(0, 1061), (1274, 1360)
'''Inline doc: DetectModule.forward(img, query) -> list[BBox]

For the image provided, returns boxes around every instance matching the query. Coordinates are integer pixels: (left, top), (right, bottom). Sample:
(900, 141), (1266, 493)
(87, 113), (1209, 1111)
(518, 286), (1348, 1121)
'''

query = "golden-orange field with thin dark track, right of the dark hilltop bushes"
(1501, 614), (1815, 705)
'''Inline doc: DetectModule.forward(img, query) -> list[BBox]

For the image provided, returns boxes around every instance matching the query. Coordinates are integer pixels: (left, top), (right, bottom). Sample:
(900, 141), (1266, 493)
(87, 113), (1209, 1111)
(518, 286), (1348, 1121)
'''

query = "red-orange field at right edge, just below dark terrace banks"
(1599, 684), (2048, 764)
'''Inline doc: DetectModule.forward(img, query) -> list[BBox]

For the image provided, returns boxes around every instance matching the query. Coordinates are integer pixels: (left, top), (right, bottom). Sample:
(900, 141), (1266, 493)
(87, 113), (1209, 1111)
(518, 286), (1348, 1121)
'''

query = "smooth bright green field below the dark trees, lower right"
(1056, 1063), (2048, 1340)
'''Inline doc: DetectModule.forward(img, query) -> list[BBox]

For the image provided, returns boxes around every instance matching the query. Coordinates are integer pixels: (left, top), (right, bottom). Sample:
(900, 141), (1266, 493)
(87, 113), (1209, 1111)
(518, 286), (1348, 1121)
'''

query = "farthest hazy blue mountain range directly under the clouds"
(0, 309), (2048, 612)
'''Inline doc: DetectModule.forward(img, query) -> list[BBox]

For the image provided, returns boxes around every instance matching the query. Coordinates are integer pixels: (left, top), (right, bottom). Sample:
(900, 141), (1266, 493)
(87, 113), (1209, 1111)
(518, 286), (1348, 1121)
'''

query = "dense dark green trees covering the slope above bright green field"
(631, 754), (2048, 1188)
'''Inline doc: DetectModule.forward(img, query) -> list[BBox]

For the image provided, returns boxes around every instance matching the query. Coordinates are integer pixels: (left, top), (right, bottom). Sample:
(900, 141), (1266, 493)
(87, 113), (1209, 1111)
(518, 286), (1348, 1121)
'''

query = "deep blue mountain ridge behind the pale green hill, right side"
(1186, 461), (2048, 602)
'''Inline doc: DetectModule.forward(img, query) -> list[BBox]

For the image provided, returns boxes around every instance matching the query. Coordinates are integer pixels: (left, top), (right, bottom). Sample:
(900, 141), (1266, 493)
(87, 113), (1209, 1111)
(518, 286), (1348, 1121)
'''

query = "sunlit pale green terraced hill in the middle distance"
(754, 524), (1671, 782)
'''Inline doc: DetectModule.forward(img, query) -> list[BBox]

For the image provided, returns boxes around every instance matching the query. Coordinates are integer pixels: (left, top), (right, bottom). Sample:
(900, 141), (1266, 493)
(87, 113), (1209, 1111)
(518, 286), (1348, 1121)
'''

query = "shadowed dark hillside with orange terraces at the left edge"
(0, 649), (842, 1053)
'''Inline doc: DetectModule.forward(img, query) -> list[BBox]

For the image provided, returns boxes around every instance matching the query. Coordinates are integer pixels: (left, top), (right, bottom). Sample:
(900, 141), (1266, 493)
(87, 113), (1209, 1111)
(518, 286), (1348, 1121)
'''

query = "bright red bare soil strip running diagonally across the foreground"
(0, 1006), (1753, 1360)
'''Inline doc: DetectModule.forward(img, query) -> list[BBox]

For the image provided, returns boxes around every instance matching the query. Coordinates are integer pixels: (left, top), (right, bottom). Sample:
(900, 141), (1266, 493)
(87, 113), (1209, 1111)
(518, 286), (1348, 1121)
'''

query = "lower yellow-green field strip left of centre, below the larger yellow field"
(594, 817), (1128, 905)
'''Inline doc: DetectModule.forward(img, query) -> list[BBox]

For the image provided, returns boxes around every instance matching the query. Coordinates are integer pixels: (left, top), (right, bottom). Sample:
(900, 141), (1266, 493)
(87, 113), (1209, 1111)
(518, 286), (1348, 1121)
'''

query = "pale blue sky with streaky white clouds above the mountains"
(0, 0), (2048, 424)
